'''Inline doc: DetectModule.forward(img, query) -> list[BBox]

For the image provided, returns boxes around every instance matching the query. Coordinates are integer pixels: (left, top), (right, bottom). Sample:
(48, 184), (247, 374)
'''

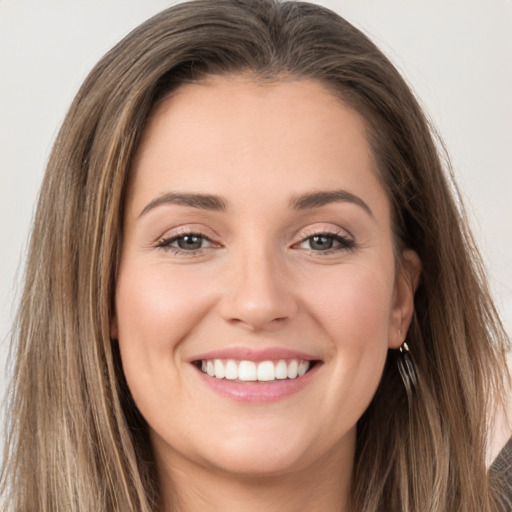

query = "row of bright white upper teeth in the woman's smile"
(201, 359), (310, 382)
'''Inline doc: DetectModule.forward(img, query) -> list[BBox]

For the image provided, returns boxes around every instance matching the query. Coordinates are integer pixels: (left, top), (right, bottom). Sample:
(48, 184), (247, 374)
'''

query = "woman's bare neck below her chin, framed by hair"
(158, 436), (353, 512)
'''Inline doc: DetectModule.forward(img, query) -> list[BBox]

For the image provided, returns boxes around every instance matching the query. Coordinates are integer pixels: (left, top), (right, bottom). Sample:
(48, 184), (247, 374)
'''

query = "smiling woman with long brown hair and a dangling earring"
(3, 0), (508, 512)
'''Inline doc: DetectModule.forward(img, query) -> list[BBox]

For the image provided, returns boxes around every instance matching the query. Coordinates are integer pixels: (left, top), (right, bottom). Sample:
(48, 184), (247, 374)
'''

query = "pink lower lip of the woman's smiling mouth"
(195, 363), (321, 402)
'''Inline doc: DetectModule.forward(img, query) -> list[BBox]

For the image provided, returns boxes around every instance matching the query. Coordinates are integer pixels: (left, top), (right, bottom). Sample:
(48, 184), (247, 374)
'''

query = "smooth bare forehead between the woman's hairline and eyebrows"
(128, 77), (384, 220)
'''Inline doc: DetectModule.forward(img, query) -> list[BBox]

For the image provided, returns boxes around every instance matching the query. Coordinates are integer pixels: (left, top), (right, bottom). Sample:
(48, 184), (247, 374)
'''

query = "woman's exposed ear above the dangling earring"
(388, 249), (421, 349)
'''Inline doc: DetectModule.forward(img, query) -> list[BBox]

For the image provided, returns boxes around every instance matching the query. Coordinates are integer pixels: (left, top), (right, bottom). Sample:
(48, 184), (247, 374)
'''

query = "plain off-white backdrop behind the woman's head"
(0, 0), (512, 439)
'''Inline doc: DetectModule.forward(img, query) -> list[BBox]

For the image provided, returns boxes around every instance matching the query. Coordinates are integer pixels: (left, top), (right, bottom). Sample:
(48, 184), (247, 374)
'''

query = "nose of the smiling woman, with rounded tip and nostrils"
(220, 245), (298, 331)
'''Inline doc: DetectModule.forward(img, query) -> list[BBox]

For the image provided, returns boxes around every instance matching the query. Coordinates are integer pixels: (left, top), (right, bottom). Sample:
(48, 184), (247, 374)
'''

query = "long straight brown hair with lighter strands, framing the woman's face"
(2, 0), (508, 512)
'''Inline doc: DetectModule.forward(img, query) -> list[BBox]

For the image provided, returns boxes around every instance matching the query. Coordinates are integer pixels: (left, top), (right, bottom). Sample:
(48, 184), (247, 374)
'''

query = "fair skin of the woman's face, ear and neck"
(112, 76), (420, 512)
